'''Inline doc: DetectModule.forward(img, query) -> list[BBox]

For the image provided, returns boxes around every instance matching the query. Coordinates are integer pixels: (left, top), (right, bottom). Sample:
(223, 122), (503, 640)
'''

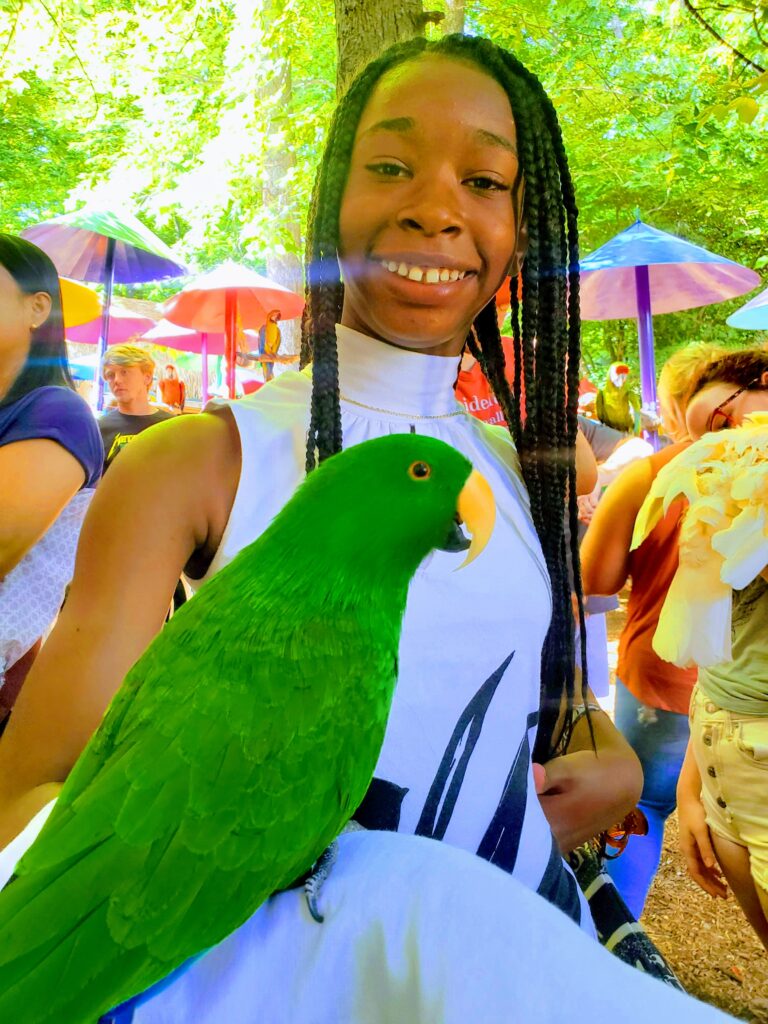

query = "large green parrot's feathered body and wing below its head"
(0, 557), (399, 1024)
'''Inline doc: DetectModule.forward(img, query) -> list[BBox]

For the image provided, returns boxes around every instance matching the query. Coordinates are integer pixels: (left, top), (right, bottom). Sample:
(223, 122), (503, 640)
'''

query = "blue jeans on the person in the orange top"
(606, 679), (688, 919)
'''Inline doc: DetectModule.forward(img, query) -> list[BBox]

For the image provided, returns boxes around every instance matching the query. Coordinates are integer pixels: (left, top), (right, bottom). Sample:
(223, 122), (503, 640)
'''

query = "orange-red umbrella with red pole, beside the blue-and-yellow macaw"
(163, 262), (304, 398)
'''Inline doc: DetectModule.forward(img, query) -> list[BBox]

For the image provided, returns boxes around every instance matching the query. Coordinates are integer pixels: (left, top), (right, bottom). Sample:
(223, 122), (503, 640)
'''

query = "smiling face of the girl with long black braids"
(339, 56), (522, 355)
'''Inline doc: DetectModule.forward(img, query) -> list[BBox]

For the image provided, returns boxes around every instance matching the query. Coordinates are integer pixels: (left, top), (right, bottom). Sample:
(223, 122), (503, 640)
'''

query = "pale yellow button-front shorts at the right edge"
(690, 686), (768, 890)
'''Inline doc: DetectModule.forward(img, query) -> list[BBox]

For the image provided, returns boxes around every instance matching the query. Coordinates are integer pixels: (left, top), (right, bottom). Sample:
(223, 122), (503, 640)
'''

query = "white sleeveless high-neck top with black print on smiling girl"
(193, 327), (592, 930)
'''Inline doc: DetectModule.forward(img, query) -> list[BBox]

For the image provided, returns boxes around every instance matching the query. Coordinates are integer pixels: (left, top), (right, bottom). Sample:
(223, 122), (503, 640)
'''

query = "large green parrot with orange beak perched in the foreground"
(0, 434), (495, 1024)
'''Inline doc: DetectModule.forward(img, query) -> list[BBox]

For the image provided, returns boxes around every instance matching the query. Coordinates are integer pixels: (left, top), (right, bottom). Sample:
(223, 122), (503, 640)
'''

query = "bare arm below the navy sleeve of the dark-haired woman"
(0, 437), (85, 580)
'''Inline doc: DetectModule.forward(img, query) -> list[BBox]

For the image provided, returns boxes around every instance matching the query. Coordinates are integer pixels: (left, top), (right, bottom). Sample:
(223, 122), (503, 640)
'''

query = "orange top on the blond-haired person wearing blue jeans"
(616, 443), (696, 715)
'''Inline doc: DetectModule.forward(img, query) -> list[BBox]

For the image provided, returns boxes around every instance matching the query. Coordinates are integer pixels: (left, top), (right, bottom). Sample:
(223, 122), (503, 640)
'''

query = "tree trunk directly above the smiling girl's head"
(335, 0), (443, 96)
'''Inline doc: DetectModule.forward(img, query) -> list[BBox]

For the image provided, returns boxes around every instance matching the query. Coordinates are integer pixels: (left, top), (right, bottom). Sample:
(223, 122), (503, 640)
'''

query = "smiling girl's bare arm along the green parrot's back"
(0, 414), (240, 848)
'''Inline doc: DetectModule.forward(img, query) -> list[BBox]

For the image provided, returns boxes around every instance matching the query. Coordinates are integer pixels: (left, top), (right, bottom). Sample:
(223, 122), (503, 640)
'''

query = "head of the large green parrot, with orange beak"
(275, 434), (496, 584)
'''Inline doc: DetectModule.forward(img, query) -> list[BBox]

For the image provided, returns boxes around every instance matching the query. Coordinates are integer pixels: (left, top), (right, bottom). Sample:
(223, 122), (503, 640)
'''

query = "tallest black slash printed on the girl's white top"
(416, 651), (518, 839)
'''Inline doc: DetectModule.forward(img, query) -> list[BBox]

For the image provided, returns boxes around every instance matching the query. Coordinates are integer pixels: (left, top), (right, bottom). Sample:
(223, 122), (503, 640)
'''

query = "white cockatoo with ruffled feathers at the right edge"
(631, 413), (768, 668)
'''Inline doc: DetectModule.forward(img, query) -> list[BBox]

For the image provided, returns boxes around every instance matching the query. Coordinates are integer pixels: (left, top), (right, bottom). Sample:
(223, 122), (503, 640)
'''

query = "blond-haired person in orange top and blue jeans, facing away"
(582, 343), (723, 919)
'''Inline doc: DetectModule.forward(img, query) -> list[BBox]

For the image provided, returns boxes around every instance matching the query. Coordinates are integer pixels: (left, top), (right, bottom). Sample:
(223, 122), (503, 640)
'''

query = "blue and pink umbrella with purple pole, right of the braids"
(580, 219), (760, 440)
